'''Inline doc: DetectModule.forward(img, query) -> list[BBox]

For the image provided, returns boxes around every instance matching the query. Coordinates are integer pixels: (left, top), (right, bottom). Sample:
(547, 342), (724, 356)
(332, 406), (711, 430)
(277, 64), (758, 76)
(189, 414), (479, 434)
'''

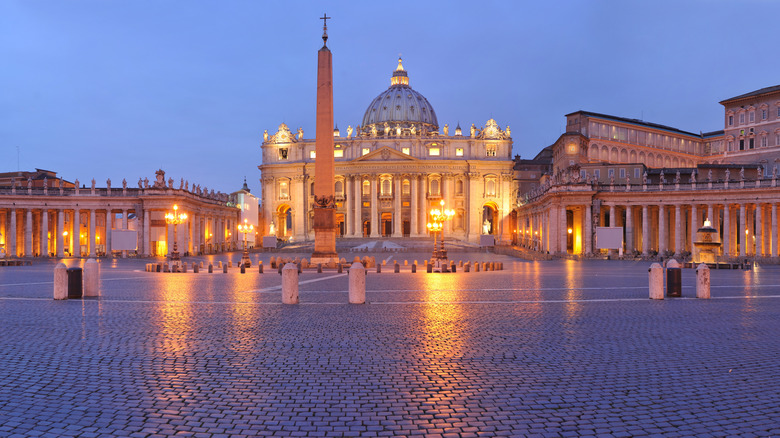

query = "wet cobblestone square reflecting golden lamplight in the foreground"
(0, 253), (780, 437)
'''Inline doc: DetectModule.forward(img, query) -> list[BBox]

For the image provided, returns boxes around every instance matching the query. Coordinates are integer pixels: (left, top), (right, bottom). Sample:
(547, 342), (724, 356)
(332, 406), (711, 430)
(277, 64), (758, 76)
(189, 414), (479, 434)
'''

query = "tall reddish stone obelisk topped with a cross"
(311, 15), (338, 264)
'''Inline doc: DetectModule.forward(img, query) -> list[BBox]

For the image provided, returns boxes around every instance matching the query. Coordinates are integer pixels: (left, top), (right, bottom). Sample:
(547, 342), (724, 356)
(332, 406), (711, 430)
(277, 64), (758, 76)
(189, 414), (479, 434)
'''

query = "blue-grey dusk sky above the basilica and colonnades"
(0, 0), (780, 194)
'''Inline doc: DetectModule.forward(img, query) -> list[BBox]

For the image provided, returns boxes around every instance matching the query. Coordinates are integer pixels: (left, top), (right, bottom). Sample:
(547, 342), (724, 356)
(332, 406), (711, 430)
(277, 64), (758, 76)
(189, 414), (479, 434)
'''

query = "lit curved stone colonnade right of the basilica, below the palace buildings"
(517, 196), (780, 258)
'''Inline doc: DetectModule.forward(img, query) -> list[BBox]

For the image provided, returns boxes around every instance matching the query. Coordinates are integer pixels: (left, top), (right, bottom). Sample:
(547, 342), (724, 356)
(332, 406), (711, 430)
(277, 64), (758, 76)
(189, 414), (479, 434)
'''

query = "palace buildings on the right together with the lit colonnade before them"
(517, 86), (780, 259)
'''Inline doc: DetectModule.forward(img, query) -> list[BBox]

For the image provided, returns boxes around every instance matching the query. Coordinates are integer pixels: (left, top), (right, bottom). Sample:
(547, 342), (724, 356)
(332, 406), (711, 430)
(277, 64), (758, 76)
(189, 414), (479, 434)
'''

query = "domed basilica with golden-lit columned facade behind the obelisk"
(258, 59), (517, 243)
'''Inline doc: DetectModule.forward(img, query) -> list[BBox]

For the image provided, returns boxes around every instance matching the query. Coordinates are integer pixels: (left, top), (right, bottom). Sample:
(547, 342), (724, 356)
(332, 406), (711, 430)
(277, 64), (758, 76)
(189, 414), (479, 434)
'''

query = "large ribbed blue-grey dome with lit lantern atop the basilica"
(362, 58), (439, 132)
